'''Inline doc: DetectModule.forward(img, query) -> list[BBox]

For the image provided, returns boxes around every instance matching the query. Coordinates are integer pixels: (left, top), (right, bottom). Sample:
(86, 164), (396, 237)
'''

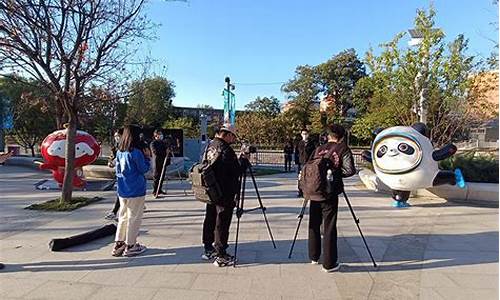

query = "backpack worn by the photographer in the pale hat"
(189, 147), (222, 204)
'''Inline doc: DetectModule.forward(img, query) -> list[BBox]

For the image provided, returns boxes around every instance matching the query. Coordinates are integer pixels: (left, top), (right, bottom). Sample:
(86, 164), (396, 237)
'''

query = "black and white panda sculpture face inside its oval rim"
(373, 134), (422, 174)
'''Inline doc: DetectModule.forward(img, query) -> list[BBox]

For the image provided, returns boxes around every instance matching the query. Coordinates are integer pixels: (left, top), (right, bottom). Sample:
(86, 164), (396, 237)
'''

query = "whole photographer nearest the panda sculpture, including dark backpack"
(302, 124), (356, 273)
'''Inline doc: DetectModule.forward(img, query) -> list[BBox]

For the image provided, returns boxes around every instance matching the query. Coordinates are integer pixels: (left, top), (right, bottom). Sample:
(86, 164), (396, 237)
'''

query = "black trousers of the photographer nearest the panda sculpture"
(309, 196), (339, 269)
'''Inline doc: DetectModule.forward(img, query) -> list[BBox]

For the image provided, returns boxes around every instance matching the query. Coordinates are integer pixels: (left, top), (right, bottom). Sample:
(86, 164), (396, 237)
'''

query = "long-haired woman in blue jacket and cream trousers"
(111, 125), (151, 256)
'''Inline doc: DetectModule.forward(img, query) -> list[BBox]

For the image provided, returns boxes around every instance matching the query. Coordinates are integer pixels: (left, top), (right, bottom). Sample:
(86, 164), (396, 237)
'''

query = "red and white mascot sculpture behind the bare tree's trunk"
(40, 129), (101, 188)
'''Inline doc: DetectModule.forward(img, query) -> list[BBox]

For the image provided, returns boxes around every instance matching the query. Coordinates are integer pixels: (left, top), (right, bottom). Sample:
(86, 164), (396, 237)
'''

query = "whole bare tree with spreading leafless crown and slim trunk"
(0, 0), (153, 201)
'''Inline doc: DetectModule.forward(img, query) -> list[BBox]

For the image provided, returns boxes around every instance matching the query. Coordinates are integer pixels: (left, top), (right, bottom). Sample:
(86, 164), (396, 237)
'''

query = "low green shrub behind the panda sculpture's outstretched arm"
(439, 152), (498, 183)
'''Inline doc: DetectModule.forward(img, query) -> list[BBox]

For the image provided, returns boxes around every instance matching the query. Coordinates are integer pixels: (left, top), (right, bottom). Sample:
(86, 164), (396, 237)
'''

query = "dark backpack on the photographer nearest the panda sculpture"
(299, 147), (340, 201)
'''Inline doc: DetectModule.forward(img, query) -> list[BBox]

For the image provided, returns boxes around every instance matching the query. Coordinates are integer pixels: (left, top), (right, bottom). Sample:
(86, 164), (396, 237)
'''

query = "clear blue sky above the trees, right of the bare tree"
(139, 0), (498, 109)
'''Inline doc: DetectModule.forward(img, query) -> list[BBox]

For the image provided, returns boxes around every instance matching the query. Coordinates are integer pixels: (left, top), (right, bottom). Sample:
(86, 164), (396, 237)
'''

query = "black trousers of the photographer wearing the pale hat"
(202, 204), (233, 255)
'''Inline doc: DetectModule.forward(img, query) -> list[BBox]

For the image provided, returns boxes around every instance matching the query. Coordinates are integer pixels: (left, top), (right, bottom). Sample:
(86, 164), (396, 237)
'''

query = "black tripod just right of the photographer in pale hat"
(233, 158), (276, 267)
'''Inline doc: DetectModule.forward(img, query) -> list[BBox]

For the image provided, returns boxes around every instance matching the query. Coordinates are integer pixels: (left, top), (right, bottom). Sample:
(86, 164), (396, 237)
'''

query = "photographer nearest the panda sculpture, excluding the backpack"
(308, 124), (356, 273)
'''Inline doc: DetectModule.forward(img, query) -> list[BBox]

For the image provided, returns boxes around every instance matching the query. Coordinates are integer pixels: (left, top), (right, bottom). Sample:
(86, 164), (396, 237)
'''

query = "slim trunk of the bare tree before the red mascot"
(61, 113), (76, 202)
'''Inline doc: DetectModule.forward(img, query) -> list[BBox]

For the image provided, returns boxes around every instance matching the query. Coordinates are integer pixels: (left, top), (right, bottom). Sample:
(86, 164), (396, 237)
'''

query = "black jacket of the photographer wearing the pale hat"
(207, 137), (243, 207)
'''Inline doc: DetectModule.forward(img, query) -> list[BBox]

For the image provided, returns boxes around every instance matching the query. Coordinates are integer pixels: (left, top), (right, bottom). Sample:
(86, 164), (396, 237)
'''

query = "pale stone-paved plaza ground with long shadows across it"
(0, 166), (498, 300)
